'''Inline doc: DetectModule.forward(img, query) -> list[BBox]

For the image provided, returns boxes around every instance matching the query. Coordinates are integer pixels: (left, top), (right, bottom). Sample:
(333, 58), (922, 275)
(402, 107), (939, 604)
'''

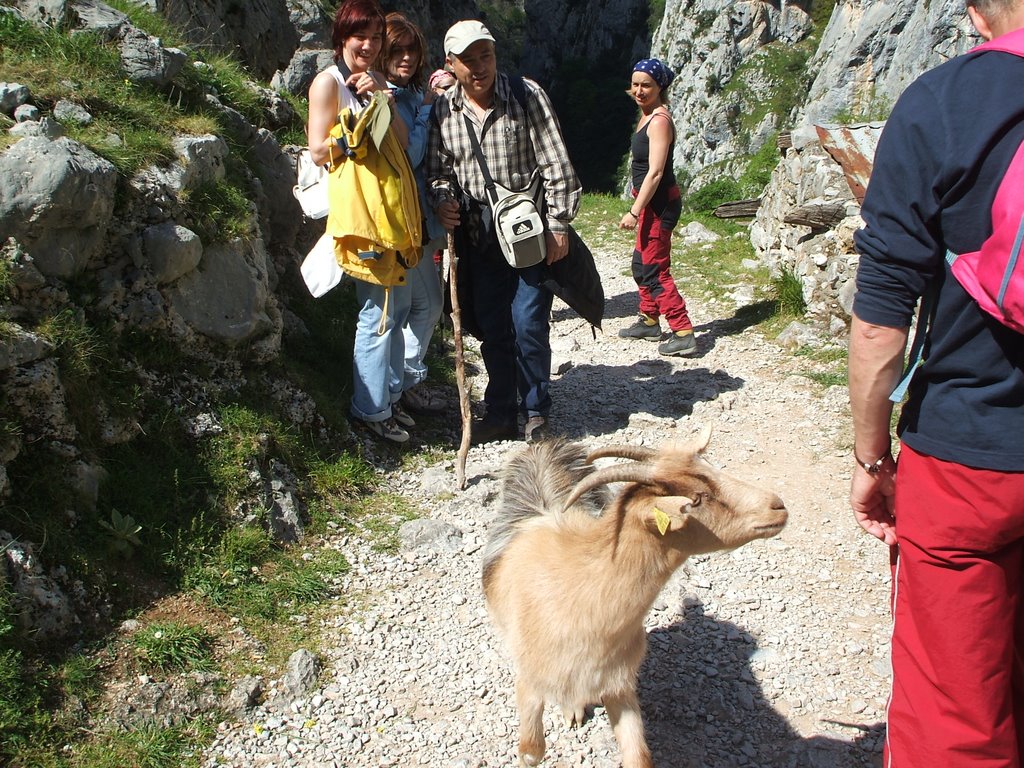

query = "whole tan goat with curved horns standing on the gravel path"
(483, 427), (787, 768)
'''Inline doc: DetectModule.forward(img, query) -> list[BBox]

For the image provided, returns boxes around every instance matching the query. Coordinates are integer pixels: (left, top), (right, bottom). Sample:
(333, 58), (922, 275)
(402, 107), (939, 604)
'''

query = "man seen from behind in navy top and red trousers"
(849, 0), (1024, 768)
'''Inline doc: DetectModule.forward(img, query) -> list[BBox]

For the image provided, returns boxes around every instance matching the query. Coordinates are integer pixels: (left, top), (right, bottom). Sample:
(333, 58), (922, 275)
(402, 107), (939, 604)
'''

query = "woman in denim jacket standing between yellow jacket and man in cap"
(382, 12), (445, 414)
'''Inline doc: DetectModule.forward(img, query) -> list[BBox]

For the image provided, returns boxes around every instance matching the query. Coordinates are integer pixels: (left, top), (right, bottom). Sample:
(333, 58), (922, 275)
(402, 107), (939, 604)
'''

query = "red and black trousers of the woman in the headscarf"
(633, 193), (693, 331)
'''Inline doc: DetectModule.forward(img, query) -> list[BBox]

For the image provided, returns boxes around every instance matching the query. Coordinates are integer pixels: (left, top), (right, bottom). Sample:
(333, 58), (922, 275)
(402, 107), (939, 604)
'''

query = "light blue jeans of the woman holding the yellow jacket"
(351, 280), (412, 421)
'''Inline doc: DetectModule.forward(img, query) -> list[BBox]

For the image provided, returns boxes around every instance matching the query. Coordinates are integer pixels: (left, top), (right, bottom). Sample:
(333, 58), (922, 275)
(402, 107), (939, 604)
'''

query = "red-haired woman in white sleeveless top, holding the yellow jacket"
(306, 0), (420, 442)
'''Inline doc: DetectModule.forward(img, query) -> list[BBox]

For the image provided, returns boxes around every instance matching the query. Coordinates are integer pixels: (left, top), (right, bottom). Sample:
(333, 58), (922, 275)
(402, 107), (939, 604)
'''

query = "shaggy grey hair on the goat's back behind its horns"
(483, 439), (607, 579)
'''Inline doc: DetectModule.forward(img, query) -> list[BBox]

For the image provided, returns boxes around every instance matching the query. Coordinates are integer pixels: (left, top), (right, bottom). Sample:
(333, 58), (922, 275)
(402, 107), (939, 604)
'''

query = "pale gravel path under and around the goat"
(205, 236), (889, 768)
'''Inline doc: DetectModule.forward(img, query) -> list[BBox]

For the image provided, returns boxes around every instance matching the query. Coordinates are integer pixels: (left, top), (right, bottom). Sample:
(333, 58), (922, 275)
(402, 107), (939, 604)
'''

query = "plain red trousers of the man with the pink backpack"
(883, 445), (1024, 768)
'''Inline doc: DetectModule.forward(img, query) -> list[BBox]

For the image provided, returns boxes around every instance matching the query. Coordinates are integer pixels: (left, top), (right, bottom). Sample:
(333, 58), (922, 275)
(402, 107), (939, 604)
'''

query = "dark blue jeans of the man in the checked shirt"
(467, 240), (554, 423)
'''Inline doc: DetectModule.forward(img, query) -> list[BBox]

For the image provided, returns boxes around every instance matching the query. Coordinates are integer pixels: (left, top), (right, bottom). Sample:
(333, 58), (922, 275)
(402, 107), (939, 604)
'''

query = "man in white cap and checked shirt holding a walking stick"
(427, 20), (581, 442)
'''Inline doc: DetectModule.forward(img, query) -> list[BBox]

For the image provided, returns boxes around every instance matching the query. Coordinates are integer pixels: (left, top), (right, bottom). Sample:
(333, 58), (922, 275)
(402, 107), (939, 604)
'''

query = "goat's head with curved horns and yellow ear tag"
(565, 427), (787, 554)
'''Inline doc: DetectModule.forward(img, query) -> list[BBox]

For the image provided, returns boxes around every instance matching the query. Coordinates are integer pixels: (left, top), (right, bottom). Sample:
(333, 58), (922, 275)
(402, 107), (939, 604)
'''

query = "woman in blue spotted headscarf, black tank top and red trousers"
(618, 58), (697, 355)
